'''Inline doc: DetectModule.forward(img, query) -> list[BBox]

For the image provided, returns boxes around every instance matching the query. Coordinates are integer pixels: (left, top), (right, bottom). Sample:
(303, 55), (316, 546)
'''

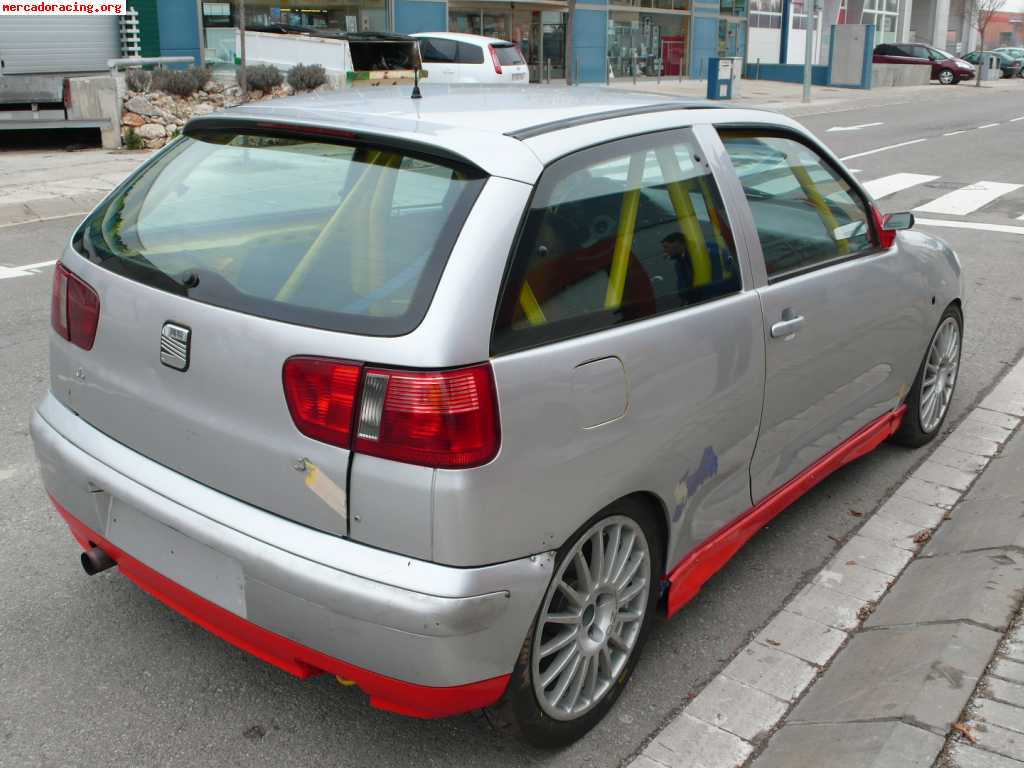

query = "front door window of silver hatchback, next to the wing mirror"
(722, 131), (872, 278)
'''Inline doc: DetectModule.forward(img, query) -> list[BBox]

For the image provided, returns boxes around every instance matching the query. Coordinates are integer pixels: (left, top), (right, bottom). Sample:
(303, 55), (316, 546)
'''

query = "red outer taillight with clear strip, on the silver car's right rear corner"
(355, 365), (499, 469)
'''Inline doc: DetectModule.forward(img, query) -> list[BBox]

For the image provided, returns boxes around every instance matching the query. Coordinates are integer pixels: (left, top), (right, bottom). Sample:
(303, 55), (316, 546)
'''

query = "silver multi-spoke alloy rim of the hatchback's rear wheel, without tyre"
(531, 515), (652, 721)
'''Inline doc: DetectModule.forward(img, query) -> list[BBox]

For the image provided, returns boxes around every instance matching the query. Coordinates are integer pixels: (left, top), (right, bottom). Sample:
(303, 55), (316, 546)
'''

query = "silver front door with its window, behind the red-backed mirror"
(720, 127), (926, 503)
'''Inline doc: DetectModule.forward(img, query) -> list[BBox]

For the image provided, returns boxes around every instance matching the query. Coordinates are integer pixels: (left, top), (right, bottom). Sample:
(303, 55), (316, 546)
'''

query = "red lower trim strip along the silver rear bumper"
(50, 497), (511, 718)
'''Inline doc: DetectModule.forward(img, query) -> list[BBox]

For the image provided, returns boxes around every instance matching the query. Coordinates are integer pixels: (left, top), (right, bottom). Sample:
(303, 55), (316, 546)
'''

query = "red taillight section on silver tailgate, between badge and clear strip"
(284, 357), (360, 449)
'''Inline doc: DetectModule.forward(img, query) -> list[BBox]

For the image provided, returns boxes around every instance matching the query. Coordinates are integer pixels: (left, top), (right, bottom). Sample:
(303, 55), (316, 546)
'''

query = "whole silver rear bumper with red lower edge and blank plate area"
(32, 395), (553, 717)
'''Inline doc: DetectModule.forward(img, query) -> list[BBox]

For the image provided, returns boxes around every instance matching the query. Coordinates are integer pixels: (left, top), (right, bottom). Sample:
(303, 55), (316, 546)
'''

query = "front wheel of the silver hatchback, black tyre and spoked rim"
(892, 304), (964, 447)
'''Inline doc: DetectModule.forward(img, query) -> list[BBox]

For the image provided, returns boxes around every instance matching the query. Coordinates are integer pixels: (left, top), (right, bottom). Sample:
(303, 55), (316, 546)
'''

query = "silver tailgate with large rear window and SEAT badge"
(51, 121), (483, 535)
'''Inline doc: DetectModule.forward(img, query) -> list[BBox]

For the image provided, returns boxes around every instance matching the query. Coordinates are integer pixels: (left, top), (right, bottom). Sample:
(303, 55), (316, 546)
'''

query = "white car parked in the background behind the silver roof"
(412, 32), (529, 85)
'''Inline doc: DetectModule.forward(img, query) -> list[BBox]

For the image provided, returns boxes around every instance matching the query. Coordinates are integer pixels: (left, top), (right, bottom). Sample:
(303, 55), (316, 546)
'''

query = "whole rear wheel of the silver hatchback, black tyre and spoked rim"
(485, 498), (665, 749)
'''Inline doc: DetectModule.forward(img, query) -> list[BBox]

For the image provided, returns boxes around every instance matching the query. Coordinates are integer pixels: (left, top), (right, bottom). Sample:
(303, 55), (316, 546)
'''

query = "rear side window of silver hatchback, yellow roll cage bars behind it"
(493, 131), (740, 352)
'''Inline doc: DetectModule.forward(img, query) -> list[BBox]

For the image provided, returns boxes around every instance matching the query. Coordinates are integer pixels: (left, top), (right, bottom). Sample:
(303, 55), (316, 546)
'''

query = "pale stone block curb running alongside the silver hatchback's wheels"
(628, 359), (1024, 768)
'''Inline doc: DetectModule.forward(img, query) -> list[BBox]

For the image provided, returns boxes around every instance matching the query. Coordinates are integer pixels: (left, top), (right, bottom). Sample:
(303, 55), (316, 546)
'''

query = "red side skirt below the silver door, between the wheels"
(668, 406), (906, 616)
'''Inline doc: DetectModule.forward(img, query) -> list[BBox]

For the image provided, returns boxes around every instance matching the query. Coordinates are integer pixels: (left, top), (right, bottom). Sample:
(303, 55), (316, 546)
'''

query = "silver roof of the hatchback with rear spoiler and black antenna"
(185, 82), (796, 183)
